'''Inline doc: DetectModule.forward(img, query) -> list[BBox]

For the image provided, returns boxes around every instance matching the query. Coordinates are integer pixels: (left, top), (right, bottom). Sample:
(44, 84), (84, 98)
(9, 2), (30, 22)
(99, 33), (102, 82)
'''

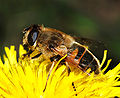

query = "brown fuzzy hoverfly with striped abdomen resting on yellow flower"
(23, 25), (100, 74)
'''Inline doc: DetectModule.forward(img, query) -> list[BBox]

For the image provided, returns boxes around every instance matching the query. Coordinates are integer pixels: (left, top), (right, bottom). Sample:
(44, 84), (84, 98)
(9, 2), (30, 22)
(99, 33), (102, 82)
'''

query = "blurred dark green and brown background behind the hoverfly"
(0, 0), (120, 65)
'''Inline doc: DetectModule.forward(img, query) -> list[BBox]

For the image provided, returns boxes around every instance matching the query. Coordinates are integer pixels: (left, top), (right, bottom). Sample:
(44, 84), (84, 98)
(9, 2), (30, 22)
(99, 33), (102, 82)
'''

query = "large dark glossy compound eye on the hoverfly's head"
(28, 32), (38, 46)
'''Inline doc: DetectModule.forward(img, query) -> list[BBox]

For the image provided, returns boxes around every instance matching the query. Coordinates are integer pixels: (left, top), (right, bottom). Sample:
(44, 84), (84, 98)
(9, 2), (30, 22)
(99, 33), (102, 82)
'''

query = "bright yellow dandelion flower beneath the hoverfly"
(0, 45), (120, 98)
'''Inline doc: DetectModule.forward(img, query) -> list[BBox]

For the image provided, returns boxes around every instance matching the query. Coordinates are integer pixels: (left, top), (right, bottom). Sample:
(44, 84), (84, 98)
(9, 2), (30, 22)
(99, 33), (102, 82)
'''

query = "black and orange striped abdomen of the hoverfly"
(66, 43), (100, 74)
